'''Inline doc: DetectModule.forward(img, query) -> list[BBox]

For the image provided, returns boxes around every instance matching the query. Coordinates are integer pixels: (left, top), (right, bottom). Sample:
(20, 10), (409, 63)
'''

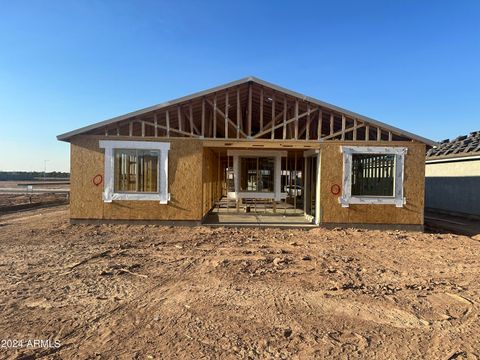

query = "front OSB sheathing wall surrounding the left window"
(70, 136), (203, 220)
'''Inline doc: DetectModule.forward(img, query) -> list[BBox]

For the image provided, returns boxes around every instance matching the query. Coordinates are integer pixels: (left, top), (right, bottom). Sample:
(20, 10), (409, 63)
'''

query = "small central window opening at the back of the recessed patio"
(240, 157), (275, 192)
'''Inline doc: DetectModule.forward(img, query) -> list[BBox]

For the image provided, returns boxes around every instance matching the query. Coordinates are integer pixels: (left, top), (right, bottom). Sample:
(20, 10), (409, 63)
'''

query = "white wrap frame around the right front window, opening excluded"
(338, 146), (408, 207)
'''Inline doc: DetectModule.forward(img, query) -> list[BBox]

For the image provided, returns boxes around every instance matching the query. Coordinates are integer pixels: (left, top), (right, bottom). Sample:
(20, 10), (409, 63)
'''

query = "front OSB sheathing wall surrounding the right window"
(320, 142), (425, 225)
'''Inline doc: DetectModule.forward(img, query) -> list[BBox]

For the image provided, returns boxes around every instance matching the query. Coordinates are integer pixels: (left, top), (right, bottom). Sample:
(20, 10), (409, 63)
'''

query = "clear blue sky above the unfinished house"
(0, 0), (480, 171)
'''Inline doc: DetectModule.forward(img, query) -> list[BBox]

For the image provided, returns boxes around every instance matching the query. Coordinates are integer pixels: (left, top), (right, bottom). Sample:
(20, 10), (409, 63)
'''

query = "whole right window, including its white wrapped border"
(338, 146), (407, 207)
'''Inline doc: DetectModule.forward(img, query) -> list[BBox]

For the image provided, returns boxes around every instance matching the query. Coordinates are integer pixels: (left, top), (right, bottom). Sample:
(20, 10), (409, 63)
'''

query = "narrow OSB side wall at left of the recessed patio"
(203, 148), (222, 215)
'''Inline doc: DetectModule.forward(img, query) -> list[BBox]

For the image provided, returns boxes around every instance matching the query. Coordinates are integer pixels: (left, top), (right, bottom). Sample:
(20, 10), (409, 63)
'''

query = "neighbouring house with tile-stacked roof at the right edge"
(425, 131), (480, 217)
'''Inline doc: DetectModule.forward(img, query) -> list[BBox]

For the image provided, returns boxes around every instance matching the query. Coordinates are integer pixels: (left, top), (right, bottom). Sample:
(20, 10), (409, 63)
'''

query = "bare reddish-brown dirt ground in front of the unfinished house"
(0, 206), (480, 359)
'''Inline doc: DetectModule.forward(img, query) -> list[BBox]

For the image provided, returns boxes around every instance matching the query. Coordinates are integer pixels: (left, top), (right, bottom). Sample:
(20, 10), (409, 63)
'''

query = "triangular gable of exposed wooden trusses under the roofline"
(92, 82), (414, 141)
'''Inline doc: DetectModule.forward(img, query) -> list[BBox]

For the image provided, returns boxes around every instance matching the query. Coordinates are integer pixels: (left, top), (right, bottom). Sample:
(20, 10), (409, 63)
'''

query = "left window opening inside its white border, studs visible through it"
(115, 149), (160, 193)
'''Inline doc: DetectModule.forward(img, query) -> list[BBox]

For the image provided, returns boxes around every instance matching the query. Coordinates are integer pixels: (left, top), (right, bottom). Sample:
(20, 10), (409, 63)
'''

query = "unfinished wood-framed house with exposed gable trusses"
(58, 77), (435, 229)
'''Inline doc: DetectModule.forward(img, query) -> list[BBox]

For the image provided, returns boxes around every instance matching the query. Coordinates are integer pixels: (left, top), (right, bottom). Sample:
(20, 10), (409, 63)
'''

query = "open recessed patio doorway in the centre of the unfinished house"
(205, 149), (305, 217)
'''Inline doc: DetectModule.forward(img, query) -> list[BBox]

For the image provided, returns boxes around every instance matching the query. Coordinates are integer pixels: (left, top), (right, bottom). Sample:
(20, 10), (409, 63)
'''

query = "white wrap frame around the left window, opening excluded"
(99, 140), (170, 204)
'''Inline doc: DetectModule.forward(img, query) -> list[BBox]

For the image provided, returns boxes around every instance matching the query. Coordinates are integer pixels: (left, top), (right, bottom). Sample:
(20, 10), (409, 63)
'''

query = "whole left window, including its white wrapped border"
(100, 140), (170, 204)
